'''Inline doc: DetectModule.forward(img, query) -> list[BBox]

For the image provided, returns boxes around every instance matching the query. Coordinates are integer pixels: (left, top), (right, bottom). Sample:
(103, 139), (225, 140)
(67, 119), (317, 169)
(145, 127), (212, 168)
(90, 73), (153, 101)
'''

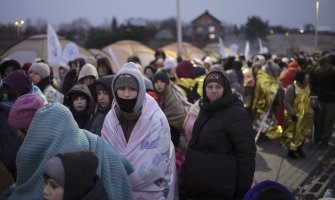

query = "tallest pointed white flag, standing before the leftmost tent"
(47, 24), (62, 65)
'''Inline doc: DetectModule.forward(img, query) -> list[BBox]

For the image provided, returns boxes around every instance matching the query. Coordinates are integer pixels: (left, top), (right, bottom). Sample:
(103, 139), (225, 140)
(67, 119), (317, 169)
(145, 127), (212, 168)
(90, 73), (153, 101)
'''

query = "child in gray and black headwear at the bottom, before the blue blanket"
(43, 151), (107, 200)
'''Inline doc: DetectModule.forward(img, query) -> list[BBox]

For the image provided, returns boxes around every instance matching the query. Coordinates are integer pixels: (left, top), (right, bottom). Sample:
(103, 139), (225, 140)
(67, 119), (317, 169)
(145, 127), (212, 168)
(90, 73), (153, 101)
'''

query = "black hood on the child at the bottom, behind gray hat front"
(57, 151), (99, 200)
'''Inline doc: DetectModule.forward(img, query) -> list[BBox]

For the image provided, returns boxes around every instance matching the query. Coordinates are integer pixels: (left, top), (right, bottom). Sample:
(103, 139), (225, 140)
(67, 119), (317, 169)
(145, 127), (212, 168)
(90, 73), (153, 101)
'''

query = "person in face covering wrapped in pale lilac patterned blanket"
(101, 62), (177, 200)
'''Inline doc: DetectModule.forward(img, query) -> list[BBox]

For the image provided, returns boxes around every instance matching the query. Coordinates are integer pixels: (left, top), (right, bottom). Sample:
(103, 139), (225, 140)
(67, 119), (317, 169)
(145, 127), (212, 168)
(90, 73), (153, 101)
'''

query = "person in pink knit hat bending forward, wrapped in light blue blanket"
(0, 94), (133, 200)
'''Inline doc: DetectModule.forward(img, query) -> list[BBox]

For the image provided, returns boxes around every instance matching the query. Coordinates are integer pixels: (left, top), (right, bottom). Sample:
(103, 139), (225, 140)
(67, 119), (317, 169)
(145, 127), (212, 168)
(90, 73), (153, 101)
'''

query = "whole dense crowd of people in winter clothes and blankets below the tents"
(0, 50), (335, 200)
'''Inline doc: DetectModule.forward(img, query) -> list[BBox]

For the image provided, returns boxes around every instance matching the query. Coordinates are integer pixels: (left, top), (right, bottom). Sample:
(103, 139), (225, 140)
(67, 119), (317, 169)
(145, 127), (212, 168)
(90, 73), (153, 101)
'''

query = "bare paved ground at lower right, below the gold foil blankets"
(255, 134), (335, 199)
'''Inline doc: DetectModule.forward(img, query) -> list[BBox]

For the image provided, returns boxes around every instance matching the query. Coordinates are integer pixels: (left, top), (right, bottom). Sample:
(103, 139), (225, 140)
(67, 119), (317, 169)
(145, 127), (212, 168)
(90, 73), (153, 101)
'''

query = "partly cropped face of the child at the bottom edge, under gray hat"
(43, 178), (64, 200)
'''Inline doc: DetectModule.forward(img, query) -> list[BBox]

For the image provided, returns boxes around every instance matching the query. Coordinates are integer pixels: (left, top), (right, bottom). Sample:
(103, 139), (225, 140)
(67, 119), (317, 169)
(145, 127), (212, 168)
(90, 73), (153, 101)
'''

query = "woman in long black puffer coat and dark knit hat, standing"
(180, 71), (256, 200)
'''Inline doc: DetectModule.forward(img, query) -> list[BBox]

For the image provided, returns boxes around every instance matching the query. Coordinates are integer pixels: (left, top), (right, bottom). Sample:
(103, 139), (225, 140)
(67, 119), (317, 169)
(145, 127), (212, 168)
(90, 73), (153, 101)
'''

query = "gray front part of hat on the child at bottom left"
(43, 156), (65, 188)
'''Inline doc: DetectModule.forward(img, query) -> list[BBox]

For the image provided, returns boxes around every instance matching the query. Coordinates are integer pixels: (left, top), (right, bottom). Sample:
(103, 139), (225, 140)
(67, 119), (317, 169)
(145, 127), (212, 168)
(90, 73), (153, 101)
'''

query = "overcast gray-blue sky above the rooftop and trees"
(0, 0), (335, 31)
